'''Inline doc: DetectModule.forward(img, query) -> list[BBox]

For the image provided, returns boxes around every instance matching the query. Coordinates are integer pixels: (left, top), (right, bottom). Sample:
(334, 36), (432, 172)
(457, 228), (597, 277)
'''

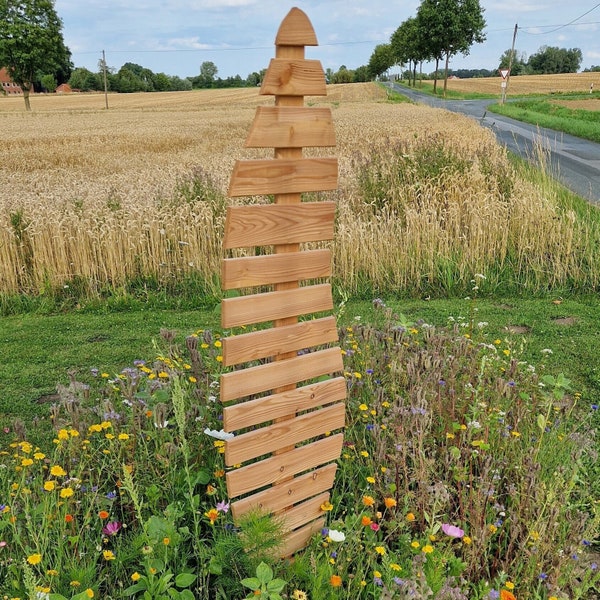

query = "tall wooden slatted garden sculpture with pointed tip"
(221, 8), (346, 556)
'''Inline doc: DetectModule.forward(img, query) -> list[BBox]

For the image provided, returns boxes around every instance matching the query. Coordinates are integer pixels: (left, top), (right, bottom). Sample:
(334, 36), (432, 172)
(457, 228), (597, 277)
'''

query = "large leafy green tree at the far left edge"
(0, 0), (72, 111)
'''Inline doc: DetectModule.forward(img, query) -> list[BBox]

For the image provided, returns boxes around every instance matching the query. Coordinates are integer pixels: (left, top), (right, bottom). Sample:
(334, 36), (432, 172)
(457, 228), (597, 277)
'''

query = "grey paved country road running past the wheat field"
(388, 84), (600, 205)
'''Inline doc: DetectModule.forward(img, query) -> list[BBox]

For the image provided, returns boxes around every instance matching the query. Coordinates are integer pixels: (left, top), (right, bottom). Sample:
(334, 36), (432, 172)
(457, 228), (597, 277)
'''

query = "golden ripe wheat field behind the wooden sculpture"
(0, 84), (588, 294)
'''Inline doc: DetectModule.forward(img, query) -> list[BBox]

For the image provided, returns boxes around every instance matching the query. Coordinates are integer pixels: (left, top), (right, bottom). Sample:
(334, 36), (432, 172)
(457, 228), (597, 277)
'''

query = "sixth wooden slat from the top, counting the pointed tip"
(221, 249), (331, 290)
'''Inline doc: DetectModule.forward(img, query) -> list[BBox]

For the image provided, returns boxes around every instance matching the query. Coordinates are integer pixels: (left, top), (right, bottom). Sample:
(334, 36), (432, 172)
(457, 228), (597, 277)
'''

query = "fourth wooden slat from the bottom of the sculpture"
(226, 433), (344, 498)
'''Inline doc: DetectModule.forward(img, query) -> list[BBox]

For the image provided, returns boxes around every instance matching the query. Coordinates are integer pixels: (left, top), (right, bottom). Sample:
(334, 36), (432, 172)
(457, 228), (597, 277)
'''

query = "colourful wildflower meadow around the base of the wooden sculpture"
(0, 300), (600, 600)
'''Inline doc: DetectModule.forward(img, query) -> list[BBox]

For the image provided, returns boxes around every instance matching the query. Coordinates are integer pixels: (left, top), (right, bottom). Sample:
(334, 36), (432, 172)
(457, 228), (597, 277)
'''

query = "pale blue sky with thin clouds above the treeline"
(55, 0), (600, 79)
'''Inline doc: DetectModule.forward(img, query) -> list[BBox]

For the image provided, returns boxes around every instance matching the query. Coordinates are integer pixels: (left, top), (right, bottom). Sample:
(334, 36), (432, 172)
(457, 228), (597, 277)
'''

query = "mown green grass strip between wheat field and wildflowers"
(0, 296), (600, 440)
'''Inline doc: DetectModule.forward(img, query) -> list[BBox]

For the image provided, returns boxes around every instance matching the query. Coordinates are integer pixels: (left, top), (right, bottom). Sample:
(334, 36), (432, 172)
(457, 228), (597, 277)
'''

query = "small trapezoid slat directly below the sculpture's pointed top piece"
(260, 58), (327, 96)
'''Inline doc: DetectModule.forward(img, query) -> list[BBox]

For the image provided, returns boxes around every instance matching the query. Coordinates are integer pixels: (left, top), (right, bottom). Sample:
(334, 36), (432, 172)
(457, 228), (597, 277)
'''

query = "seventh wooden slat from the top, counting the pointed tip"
(221, 283), (333, 329)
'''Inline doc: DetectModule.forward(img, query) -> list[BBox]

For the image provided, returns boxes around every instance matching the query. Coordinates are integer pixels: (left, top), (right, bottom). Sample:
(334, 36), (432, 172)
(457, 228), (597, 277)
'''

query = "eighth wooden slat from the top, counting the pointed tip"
(222, 316), (338, 367)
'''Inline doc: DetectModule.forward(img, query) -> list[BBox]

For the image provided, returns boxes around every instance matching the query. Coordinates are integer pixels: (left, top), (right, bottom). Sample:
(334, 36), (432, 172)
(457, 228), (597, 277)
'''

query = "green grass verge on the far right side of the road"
(488, 96), (600, 143)
